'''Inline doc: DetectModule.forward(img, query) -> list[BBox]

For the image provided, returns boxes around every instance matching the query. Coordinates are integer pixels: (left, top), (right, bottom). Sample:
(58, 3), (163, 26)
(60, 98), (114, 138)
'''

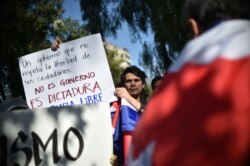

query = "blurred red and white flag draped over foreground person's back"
(128, 20), (250, 166)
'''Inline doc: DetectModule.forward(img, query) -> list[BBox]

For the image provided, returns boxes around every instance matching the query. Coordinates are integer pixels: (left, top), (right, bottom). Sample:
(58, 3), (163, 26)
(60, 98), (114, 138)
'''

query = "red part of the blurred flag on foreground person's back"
(132, 55), (250, 166)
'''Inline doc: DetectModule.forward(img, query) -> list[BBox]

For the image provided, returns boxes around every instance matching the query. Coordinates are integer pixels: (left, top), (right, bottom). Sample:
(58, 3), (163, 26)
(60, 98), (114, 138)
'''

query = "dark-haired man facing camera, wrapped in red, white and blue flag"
(111, 66), (146, 165)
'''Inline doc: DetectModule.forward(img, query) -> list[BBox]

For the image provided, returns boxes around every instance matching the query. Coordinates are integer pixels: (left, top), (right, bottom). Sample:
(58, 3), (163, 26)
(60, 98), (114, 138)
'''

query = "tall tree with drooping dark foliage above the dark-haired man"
(80, 0), (186, 76)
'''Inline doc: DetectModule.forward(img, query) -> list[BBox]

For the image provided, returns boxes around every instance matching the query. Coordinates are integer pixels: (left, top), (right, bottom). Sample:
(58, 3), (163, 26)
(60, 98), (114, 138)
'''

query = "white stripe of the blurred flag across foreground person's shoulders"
(169, 20), (250, 72)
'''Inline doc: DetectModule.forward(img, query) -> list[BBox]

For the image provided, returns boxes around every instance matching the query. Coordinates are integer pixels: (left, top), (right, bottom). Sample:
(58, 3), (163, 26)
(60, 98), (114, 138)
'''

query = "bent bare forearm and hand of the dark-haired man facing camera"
(115, 87), (141, 111)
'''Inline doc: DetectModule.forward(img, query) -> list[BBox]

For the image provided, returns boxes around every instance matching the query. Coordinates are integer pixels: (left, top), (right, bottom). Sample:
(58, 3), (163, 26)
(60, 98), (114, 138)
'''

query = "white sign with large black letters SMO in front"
(0, 102), (112, 166)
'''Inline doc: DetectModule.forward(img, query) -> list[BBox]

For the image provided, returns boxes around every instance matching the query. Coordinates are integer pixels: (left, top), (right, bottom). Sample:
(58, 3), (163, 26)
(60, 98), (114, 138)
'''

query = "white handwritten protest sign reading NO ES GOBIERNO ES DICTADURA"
(19, 34), (115, 109)
